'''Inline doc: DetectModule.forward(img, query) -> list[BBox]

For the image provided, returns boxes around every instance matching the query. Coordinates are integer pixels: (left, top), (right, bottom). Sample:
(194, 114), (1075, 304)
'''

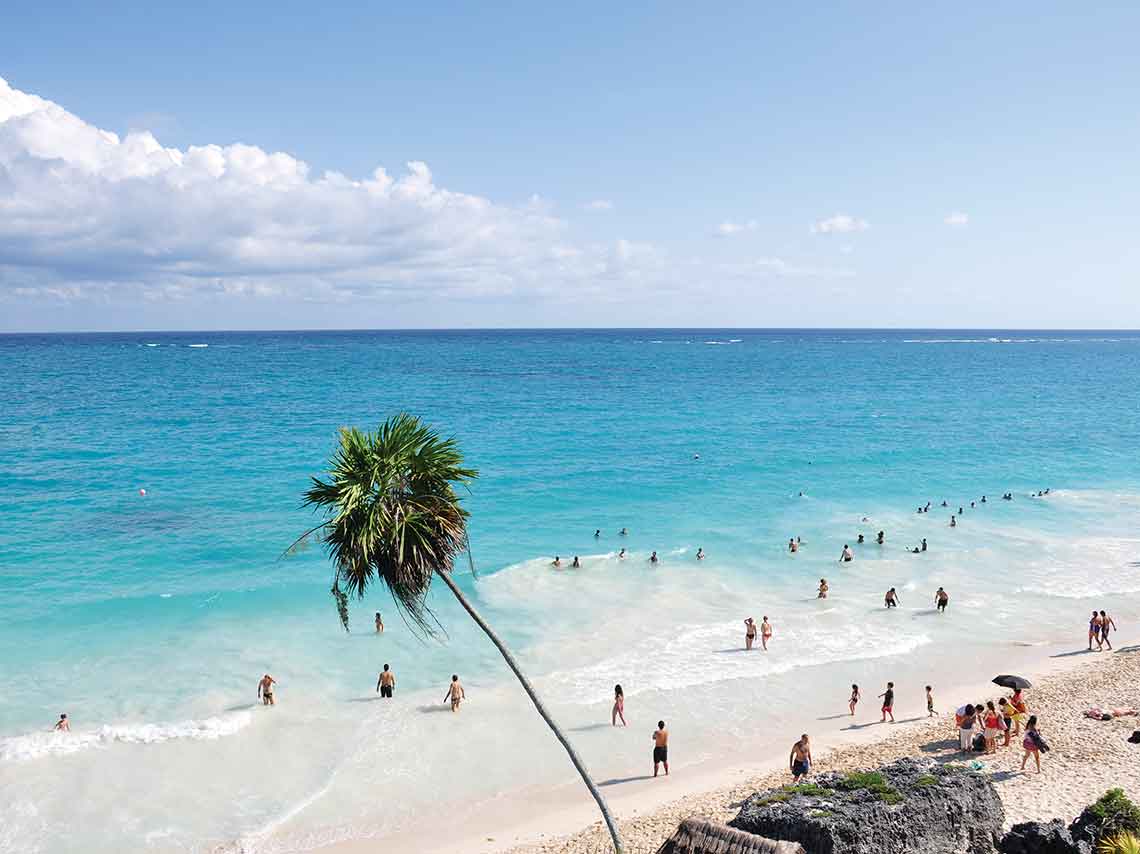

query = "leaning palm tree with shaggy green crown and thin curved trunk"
(290, 413), (622, 854)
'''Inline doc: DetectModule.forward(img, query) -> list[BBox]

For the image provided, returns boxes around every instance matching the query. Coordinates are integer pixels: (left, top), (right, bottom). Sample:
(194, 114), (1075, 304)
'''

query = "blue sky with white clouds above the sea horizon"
(0, 0), (1140, 332)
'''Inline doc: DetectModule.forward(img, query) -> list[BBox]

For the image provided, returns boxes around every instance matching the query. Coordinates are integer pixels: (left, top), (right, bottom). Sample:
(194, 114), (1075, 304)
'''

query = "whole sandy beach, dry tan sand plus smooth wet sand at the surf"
(319, 635), (1140, 854)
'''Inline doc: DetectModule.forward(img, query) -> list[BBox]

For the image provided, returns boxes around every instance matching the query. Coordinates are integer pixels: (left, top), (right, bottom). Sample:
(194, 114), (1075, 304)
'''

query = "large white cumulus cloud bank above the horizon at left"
(0, 79), (663, 300)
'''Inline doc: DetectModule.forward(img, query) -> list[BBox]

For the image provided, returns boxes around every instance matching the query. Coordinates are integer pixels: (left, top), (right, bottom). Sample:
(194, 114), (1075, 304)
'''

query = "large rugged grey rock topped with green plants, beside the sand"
(728, 759), (1004, 854)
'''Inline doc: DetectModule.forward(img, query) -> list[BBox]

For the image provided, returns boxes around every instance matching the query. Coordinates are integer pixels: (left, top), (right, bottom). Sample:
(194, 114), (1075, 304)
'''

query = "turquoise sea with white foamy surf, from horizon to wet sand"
(0, 330), (1140, 852)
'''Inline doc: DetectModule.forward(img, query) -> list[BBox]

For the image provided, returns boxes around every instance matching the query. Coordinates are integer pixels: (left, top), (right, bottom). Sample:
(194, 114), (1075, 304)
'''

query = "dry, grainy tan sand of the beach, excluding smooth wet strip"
(476, 646), (1140, 854)
